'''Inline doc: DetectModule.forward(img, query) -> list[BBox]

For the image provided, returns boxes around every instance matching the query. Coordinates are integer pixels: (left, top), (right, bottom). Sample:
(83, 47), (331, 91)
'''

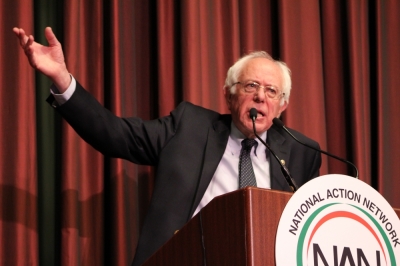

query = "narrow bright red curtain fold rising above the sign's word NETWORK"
(344, 1), (374, 183)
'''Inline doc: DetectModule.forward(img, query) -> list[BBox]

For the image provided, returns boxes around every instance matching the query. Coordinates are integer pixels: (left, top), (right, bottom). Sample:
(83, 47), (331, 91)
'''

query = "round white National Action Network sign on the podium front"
(275, 175), (400, 266)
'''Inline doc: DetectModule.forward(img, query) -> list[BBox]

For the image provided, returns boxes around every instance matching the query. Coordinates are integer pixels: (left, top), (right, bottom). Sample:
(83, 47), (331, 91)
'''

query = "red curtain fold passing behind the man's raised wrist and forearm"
(60, 1), (104, 265)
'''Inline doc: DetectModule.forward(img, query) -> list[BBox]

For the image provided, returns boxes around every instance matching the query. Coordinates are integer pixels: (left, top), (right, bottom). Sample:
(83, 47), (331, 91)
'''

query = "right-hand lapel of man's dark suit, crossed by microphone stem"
(267, 126), (291, 191)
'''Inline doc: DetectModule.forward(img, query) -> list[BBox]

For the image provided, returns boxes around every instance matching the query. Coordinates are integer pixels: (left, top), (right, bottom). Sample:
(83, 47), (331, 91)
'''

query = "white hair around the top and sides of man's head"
(225, 51), (292, 105)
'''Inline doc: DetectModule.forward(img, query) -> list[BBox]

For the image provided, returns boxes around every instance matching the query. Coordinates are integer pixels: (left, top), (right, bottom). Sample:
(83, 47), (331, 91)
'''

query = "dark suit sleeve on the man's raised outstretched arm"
(49, 82), (185, 165)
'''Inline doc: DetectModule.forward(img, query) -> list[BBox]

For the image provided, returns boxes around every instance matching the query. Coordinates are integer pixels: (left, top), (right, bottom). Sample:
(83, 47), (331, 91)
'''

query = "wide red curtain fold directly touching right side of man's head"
(278, 0), (331, 174)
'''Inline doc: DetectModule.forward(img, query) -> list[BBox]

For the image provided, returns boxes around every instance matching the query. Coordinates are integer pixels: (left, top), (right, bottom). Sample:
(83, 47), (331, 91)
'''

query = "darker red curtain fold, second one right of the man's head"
(313, 1), (352, 177)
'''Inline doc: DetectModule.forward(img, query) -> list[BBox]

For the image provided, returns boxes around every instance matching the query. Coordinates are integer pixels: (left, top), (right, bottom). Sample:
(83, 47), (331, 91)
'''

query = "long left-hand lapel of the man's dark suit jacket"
(188, 116), (231, 219)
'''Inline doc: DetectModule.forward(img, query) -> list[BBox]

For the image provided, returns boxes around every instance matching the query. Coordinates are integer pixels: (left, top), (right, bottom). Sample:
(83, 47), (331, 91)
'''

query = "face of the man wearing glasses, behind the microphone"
(224, 58), (287, 138)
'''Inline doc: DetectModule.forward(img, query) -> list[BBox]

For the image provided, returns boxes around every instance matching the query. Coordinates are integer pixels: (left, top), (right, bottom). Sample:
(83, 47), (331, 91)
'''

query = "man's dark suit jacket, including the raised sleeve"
(48, 83), (321, 265)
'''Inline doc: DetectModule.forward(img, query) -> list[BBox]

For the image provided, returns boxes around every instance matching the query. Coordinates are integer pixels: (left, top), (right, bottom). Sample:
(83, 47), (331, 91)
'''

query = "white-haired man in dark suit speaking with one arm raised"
(14, 28), (321, 265)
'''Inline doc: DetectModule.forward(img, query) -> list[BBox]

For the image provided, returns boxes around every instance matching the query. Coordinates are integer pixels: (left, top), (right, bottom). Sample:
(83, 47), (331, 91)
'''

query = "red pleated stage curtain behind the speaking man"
(0, 0), (400, 266)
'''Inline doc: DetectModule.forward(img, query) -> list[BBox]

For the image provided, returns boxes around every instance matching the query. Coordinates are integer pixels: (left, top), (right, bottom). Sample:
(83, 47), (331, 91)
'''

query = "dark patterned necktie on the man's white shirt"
(239, 139), (258, 188)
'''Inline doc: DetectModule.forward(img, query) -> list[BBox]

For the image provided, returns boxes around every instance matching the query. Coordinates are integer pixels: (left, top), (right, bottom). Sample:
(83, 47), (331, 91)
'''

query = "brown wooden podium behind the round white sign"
(143, 187), (400, 266)
